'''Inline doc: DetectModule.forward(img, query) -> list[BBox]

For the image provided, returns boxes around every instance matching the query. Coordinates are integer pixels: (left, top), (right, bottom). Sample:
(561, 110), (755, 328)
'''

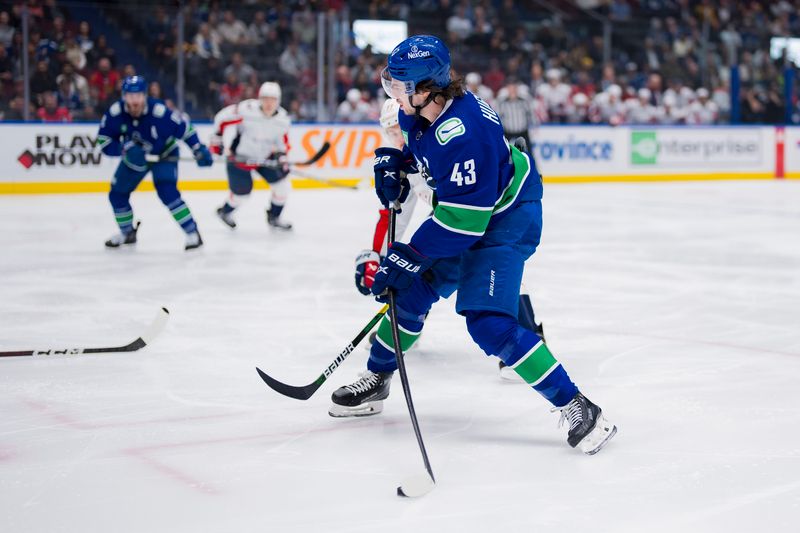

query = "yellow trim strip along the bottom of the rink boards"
(0, 172), (800, 194)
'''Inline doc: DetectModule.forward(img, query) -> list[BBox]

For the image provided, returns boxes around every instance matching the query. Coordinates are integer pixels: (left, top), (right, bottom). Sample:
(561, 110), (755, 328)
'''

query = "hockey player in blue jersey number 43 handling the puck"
(332, 35), (617, 454)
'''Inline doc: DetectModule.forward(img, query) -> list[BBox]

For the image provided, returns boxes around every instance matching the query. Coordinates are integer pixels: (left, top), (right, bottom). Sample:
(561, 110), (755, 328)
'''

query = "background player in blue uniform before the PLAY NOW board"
(97, 76), (213, 250)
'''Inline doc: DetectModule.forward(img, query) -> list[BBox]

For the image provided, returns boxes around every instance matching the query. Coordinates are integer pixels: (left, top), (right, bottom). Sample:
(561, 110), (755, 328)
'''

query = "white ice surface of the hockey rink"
(0, 181), (800, 533)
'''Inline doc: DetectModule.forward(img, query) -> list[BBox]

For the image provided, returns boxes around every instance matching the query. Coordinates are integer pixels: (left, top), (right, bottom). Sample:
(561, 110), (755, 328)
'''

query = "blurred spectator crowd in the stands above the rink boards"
(0, 0), (800, 127)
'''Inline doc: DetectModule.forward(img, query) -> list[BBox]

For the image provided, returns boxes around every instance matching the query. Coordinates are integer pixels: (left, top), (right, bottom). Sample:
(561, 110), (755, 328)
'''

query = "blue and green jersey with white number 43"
(399, 92), (542, 258)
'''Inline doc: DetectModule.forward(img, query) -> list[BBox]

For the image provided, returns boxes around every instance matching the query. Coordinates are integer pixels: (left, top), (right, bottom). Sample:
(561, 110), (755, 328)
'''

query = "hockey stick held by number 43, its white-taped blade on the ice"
(387, 206), (436, 498)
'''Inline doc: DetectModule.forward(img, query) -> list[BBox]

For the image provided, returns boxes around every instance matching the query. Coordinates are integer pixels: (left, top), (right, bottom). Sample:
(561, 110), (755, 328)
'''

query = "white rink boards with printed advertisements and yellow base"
(0, 123), (800, 194)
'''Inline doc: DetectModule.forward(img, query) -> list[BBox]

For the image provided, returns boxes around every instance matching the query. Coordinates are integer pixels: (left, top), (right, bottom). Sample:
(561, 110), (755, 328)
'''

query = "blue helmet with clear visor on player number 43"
(381, 35), (450, 98)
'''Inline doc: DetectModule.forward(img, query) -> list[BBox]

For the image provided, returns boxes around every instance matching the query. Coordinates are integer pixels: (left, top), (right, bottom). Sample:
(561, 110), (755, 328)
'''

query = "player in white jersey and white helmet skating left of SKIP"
(210, 81), (292, 230)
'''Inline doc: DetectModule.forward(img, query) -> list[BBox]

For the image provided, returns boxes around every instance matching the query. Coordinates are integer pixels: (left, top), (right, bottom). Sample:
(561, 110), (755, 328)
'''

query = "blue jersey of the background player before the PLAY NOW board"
(97, 98), (200, 158)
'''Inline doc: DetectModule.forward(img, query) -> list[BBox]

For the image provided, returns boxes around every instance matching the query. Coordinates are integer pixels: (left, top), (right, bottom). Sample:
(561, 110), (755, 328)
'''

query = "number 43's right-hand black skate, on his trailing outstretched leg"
(553, 392), (617, 455)
